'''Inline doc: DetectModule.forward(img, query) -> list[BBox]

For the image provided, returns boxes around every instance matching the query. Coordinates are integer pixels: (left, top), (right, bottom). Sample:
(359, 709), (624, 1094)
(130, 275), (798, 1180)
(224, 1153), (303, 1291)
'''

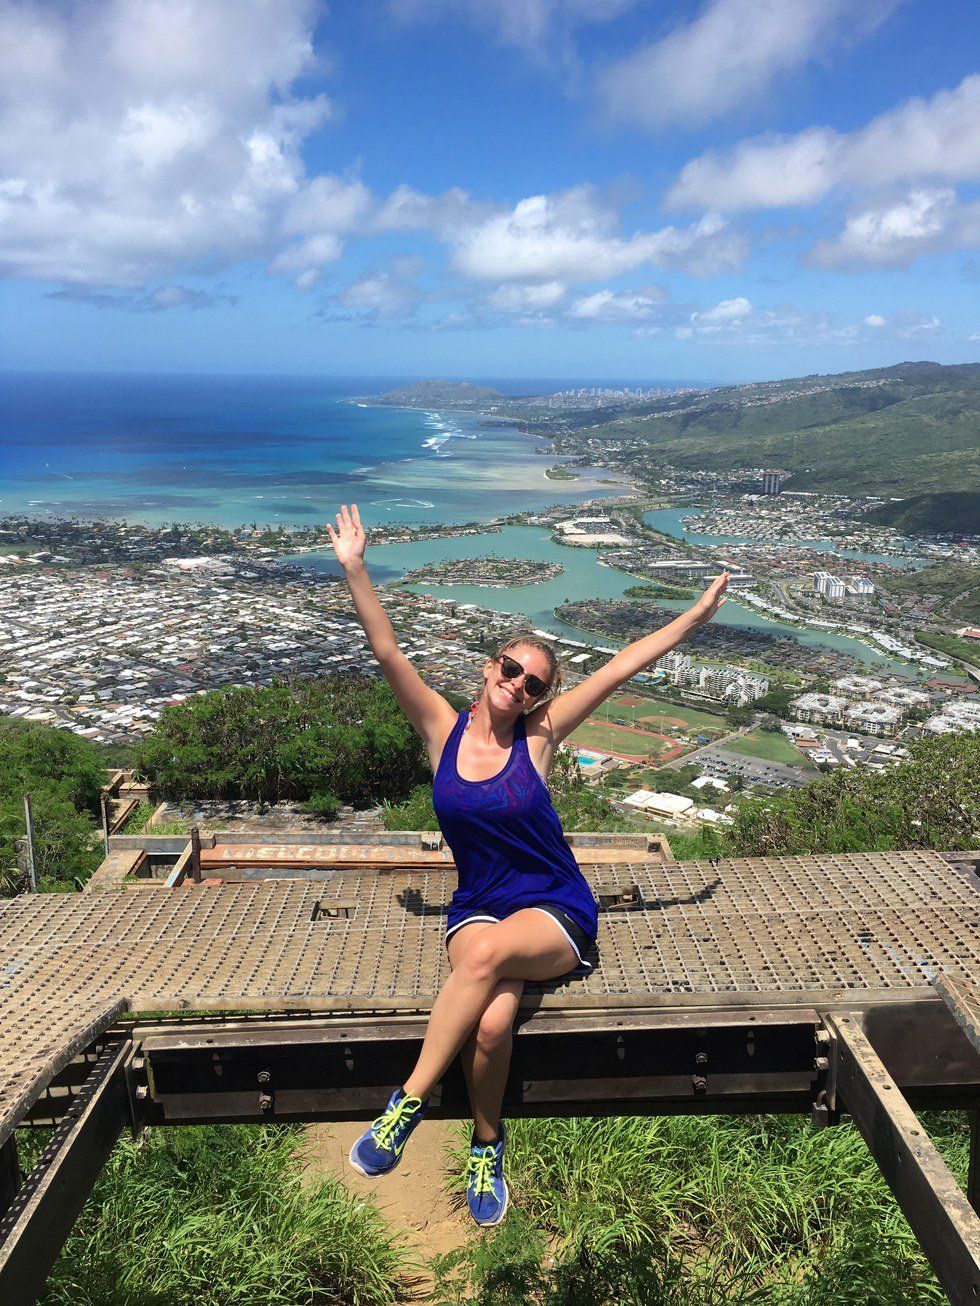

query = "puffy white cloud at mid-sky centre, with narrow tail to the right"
(447, 185), (746, 282)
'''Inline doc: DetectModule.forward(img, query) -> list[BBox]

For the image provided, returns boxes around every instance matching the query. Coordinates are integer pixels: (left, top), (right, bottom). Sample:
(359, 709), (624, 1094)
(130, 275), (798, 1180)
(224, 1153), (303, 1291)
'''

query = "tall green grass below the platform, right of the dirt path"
(433, 1113), (968, 1306)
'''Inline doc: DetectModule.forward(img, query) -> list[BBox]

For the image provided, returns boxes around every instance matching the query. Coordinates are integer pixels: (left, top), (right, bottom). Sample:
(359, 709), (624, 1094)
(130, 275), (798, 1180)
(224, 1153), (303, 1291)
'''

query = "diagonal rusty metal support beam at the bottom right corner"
(828, 1013), (980, 1306)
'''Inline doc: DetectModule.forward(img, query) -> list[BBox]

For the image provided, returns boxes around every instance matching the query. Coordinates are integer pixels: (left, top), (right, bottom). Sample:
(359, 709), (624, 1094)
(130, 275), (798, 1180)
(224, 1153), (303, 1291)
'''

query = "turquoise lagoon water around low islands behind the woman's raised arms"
(291, 526), (911, 674)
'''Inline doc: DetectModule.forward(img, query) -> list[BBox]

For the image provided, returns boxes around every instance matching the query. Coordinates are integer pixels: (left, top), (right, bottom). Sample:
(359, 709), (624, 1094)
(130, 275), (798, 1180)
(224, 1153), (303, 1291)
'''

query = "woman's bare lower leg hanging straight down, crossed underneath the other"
(449, 922), (524, 1143)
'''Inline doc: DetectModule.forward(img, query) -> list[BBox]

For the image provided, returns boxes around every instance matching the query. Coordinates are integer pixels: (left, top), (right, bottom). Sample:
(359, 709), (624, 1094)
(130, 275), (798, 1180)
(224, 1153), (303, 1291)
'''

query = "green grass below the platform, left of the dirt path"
(28, 1124), (408, 1306)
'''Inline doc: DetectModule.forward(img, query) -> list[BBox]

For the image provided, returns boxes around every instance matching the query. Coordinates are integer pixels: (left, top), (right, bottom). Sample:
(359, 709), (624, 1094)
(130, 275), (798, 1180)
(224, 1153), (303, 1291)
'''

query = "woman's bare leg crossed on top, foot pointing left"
(404, 908), (578, 1097)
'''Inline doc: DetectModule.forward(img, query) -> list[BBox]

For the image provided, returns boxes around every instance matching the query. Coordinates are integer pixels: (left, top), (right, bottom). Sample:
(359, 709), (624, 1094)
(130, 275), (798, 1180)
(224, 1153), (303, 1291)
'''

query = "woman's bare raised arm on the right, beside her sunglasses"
(529, 572), (728, 748)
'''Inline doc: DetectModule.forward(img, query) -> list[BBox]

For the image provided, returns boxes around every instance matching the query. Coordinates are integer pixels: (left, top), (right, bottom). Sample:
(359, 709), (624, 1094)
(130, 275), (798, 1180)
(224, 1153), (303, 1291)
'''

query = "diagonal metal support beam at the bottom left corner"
(0, 1043), (131, 1306)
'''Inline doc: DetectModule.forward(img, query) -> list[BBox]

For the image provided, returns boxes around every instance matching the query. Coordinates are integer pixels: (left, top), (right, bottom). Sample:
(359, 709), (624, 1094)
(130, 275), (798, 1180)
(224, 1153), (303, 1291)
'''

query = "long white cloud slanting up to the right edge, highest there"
(666, 74), (980, 212)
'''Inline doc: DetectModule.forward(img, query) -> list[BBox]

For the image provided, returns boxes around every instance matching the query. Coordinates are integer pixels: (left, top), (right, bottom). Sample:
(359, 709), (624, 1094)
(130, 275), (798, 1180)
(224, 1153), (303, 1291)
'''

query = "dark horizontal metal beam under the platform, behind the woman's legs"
(136, 1011), (822, 1123)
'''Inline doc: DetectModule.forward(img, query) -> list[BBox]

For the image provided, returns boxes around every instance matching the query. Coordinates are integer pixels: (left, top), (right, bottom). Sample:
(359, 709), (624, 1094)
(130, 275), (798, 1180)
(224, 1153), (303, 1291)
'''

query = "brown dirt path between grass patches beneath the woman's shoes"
(304, 1121), (476, 1299)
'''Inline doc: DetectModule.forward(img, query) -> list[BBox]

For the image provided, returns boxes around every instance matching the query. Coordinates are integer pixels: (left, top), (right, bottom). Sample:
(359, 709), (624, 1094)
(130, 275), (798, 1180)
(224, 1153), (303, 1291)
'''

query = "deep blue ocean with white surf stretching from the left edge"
(0, 372), (629, 526)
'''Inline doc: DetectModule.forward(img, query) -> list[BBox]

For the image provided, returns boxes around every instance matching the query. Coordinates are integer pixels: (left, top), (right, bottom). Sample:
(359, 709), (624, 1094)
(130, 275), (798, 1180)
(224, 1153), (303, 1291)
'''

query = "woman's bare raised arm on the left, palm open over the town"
(327, 503), (456, 756)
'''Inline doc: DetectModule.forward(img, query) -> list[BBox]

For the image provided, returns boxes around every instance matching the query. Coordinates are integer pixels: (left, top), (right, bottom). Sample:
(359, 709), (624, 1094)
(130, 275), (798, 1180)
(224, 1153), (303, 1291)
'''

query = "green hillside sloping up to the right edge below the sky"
(589, 363), (980, 496)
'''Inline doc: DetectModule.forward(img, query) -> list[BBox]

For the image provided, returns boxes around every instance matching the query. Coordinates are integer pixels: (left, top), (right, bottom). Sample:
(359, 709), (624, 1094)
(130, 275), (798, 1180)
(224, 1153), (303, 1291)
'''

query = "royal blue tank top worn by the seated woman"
(433, 712), (598, 939)
